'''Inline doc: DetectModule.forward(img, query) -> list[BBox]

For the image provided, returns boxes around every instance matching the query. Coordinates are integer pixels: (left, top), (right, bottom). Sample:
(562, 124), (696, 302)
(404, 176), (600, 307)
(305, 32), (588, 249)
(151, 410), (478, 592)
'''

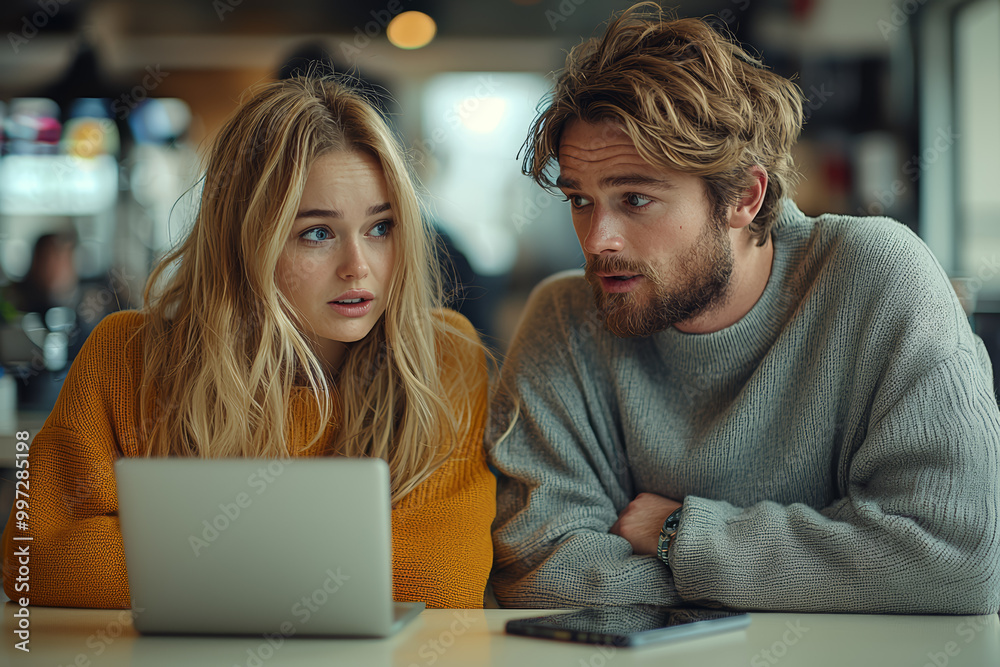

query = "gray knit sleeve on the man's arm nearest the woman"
(488, 274), (679, 608)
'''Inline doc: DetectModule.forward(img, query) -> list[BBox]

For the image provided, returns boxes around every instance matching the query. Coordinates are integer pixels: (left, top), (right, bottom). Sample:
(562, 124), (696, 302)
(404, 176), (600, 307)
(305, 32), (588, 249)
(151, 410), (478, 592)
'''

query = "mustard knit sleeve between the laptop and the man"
(392, 310), (496, 608)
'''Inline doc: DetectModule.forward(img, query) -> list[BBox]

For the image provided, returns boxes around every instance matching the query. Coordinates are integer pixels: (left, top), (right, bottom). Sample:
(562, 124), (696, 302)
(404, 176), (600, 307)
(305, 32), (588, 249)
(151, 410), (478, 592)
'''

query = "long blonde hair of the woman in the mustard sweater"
(140, 76), (468, 502)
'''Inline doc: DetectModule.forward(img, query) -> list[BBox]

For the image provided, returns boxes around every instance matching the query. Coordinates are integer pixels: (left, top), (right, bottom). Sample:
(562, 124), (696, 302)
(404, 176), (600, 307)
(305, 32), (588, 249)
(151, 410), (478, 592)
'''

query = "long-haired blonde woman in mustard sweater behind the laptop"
(4, 77), (494, 607)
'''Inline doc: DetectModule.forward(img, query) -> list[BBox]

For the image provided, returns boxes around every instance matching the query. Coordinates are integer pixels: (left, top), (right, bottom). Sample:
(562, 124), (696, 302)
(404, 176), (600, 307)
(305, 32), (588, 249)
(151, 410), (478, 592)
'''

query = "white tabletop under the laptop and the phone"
(0, 603), (1000, 667)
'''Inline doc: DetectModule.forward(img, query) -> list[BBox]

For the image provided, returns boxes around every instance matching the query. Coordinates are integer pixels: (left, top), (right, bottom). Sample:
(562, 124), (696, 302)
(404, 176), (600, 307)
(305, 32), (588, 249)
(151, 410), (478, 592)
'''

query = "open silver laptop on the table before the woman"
(115, 458), (424, 637)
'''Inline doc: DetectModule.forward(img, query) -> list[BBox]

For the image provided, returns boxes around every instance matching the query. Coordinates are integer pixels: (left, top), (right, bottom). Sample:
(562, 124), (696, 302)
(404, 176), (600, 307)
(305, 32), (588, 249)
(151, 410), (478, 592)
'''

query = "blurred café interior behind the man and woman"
(0, 0), (1000, 412)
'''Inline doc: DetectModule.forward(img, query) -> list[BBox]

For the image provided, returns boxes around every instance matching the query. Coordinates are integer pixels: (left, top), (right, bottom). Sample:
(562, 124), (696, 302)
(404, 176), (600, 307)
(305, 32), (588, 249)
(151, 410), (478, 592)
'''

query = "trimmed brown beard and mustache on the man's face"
(586, 217), (733, 338)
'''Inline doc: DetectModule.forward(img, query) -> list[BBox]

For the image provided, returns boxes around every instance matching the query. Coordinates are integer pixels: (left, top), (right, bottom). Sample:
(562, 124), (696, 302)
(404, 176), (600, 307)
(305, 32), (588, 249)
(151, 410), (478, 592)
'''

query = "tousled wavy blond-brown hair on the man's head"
(522, 2), (803, 245)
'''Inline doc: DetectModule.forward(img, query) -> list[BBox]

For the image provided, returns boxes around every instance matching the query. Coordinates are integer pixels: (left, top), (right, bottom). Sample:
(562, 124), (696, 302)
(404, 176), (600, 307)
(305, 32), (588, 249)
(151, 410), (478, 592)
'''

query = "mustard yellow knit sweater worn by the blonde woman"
(3, 310), (495, 608)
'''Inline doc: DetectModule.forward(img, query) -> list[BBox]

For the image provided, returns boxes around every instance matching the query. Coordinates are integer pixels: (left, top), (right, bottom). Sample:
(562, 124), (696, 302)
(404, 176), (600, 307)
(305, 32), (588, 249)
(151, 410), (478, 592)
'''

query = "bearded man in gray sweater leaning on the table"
(487, 3), (1000, 614)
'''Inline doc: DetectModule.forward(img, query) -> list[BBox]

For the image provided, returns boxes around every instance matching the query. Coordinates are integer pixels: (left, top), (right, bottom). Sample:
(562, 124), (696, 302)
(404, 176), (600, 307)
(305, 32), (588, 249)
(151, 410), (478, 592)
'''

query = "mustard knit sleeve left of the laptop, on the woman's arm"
(3, 312), (141, 608)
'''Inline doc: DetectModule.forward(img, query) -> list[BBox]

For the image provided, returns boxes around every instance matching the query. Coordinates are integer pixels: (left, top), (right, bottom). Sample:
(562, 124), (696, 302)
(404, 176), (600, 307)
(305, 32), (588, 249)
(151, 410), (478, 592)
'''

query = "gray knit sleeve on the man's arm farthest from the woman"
(670, 231), (1000, 614)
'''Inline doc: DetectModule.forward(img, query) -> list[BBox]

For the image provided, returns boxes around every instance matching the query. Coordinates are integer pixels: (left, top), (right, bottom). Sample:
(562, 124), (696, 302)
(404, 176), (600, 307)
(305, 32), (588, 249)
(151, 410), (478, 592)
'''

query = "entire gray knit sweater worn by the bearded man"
(488, 202), (1000, 614)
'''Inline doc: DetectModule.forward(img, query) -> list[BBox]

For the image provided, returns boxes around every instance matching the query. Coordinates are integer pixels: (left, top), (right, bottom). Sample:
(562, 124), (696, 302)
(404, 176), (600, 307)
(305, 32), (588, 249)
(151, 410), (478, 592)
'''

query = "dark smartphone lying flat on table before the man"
(506, 604), (750, 646)
